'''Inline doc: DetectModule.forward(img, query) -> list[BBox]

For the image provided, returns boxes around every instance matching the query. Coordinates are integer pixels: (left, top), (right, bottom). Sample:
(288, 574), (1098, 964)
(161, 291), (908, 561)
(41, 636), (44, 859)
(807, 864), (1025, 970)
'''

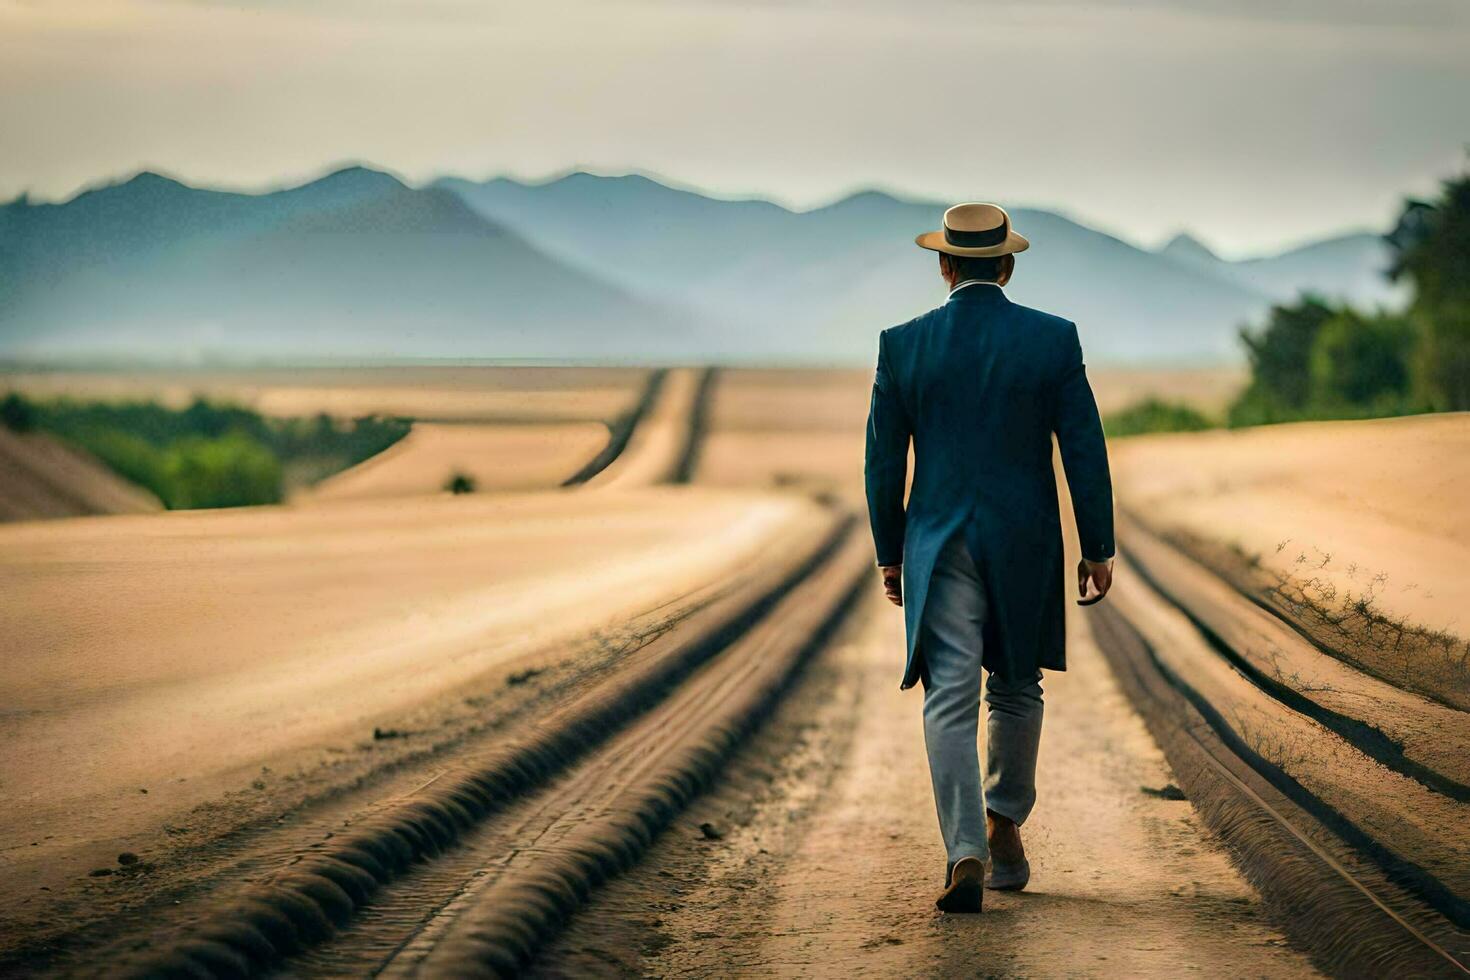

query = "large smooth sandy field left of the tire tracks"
(0, 491), (817, 912)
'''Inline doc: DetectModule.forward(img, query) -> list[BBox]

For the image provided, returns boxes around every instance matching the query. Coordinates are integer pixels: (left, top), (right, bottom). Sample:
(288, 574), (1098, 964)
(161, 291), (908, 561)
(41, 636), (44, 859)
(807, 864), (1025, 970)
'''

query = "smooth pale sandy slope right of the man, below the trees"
(1111, 414), (1470, 635)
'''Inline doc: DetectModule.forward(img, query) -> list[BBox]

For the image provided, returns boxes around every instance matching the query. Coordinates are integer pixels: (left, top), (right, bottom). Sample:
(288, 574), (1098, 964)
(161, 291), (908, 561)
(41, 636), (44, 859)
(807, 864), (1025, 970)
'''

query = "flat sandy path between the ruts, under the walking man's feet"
(537, 593), (1314, 977)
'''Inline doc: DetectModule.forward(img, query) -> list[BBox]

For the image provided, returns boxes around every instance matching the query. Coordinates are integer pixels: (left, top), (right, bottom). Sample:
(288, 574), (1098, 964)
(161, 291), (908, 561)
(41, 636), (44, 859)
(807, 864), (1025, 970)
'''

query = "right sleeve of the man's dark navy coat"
(1054, 323), (1114, 561)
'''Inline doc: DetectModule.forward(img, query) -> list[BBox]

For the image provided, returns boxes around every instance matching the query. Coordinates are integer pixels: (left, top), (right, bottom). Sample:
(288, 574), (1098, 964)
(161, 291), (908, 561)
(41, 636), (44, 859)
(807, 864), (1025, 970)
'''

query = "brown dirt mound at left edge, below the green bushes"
(0, 428), (163, 520)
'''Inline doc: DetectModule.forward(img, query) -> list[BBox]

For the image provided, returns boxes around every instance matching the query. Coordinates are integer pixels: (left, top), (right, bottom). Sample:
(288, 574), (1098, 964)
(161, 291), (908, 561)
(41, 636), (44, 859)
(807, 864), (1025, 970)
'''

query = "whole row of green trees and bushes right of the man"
(1104, 166), (1470, 436)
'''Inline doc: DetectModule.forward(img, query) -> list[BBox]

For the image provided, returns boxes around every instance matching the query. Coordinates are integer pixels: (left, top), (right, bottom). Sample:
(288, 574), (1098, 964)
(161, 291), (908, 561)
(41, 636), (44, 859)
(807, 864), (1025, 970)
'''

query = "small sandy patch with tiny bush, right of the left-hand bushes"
(301, 422), (609, 502)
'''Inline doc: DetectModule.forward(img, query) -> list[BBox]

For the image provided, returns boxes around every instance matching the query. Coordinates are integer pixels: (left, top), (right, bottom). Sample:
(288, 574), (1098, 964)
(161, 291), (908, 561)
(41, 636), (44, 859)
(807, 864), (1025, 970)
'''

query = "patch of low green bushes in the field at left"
(0, 392), (409, 510)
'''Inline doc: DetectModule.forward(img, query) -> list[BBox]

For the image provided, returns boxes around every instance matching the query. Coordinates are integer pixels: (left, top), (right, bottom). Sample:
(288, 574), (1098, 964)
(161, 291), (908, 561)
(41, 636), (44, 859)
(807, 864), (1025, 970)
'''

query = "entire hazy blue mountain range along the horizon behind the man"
(0, 167), (1399, 364)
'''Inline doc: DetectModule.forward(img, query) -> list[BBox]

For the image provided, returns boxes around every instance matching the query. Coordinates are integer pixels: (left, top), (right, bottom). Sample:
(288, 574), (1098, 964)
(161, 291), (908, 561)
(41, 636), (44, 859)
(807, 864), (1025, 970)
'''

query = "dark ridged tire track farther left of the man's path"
(111, 516), (853, 976)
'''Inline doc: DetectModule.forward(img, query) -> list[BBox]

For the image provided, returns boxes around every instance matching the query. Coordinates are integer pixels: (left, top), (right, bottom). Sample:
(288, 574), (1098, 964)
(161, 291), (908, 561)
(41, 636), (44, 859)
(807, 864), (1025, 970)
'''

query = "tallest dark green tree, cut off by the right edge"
(1386, 173), (1470, 411)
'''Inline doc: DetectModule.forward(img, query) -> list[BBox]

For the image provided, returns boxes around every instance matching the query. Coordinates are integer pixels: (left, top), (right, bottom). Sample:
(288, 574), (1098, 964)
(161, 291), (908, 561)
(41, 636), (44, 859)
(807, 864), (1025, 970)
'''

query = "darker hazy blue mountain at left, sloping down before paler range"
(0, 167), (688, 360)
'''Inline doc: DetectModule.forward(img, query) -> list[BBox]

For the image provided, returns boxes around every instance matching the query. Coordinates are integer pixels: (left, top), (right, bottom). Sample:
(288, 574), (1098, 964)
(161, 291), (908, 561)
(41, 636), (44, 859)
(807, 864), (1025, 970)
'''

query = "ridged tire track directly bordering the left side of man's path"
(384, 538), (870, 977)
